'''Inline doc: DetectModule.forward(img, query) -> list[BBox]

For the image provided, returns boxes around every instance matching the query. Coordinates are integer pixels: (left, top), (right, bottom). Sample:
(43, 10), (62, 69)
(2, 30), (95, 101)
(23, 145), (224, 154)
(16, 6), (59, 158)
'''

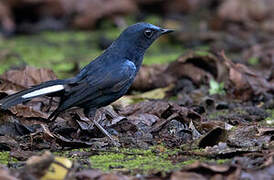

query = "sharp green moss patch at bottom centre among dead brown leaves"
(74, 145), (195, 174)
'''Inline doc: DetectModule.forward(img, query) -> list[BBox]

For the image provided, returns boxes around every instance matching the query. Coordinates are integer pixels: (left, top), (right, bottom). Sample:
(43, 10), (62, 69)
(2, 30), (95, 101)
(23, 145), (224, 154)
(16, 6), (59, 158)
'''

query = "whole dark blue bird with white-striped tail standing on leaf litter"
(0, 22), (172, 145)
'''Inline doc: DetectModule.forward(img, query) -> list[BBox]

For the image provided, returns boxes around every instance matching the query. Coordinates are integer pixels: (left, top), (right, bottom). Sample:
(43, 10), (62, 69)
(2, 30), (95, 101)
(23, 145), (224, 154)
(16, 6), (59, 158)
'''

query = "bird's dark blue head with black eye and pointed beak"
(109, 22), (173, 59)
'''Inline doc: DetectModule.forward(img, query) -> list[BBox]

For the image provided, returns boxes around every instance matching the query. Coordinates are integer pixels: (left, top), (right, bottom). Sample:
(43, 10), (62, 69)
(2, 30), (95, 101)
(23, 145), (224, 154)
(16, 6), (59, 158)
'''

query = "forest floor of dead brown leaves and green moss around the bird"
(0, 14), (274, 180)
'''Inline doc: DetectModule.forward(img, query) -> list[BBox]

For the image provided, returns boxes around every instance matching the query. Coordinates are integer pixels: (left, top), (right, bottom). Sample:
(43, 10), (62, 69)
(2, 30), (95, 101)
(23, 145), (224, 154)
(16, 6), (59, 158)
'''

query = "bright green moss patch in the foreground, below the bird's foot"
(90, 149), (175, 173)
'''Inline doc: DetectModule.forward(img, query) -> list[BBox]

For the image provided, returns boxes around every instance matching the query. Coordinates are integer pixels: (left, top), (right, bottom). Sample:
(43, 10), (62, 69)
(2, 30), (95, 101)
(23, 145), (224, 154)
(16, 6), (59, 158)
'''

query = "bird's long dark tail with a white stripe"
(0, 80), (65, 109)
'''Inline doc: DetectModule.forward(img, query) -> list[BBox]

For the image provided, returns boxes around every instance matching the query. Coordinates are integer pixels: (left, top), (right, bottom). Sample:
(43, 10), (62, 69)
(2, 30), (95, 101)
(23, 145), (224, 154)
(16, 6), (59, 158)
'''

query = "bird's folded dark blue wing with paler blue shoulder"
(49, 60), (136, 117)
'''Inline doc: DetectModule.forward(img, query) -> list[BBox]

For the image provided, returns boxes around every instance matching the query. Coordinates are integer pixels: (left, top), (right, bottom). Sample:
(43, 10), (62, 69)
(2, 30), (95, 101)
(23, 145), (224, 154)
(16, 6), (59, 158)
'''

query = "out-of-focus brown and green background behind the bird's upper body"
(0, 0), (274, 78)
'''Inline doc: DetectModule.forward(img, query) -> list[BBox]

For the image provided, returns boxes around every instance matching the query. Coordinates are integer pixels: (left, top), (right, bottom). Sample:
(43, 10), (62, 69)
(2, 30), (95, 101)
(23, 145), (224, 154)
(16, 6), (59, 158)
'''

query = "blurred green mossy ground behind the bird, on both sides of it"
(0, 17), (184, 78)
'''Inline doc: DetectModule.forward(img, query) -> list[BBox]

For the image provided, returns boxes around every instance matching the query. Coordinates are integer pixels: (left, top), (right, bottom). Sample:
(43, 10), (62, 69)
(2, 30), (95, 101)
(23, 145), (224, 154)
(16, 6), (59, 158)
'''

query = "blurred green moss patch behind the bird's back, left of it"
(0, 31), (101, 77)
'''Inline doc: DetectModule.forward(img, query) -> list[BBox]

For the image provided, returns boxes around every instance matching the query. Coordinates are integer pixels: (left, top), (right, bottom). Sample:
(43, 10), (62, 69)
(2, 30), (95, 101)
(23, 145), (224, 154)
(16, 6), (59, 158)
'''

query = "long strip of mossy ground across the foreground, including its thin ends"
(50, 145), (230, 175)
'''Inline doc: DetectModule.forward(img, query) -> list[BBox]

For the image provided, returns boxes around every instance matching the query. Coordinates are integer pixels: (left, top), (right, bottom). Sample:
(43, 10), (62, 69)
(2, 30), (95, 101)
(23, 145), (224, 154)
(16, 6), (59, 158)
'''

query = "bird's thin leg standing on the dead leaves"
(84, 108), (120, 146)
